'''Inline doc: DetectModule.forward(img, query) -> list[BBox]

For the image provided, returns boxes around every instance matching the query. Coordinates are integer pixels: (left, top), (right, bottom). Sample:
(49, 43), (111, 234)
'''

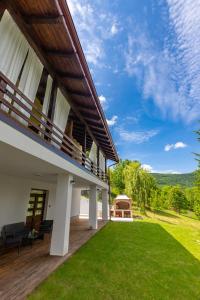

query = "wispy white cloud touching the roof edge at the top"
(67, 0), (119, 67)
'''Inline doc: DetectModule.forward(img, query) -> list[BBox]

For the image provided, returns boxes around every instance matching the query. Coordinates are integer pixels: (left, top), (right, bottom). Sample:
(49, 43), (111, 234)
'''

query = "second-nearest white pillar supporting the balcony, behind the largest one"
(89, 185), (98, 229)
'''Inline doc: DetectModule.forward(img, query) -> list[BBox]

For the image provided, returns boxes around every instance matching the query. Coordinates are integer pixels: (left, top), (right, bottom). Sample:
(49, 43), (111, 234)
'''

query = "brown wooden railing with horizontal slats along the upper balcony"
(0, 72), (107, 182)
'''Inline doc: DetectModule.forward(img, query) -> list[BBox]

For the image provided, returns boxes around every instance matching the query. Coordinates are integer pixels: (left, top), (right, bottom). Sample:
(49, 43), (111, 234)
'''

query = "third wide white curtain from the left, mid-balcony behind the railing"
(53, 89), (70, 148)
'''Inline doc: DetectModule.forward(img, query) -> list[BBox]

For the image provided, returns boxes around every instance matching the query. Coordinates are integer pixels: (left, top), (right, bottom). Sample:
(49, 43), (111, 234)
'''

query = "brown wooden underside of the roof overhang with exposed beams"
(5, 0), (118, 161)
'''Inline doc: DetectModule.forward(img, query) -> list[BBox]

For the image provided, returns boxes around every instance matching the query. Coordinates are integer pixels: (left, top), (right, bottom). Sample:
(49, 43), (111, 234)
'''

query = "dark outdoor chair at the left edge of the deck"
(1, 222), (29, 254)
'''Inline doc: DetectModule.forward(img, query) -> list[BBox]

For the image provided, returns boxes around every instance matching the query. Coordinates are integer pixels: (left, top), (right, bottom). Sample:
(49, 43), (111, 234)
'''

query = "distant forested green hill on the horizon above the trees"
(152, 173), (195, 187)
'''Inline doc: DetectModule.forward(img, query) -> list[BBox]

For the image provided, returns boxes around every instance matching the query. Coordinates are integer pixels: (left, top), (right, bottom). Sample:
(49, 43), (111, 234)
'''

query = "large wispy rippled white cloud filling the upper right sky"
(125, 0), (200, 122)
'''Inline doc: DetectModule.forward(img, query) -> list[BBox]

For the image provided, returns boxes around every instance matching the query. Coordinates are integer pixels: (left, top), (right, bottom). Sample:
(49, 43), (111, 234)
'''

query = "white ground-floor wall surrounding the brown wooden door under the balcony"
(0, 174), (55, 231)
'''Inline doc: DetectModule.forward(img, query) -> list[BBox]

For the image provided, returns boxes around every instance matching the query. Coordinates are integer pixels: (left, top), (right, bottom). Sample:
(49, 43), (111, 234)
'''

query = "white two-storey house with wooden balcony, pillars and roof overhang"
(0, 0), (118, 256)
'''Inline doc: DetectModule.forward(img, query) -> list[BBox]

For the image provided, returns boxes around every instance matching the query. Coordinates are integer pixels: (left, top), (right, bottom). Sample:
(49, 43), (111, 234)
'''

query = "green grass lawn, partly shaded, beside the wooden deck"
(29, 212), (200, 300)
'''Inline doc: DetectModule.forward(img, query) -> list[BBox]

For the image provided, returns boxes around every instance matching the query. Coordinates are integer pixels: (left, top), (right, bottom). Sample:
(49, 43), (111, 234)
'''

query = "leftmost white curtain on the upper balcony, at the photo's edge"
(0, 10), (29, 111)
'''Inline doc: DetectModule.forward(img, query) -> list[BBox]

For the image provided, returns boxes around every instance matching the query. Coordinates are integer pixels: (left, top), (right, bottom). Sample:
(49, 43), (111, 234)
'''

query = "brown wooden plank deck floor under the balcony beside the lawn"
(0, 220), (106, 300)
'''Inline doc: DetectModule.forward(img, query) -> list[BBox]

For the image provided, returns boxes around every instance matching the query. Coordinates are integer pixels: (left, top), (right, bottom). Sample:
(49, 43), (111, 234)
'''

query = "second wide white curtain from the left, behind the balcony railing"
(15, 48), (43, 125)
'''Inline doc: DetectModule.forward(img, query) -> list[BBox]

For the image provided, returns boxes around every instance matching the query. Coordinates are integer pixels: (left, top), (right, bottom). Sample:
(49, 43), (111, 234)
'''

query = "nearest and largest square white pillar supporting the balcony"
(50, 174), (73, 256)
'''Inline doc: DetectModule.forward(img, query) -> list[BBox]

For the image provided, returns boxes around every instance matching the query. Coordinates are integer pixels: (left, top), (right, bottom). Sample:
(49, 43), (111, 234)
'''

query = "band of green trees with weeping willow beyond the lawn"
(109, 160), (200, 219)
